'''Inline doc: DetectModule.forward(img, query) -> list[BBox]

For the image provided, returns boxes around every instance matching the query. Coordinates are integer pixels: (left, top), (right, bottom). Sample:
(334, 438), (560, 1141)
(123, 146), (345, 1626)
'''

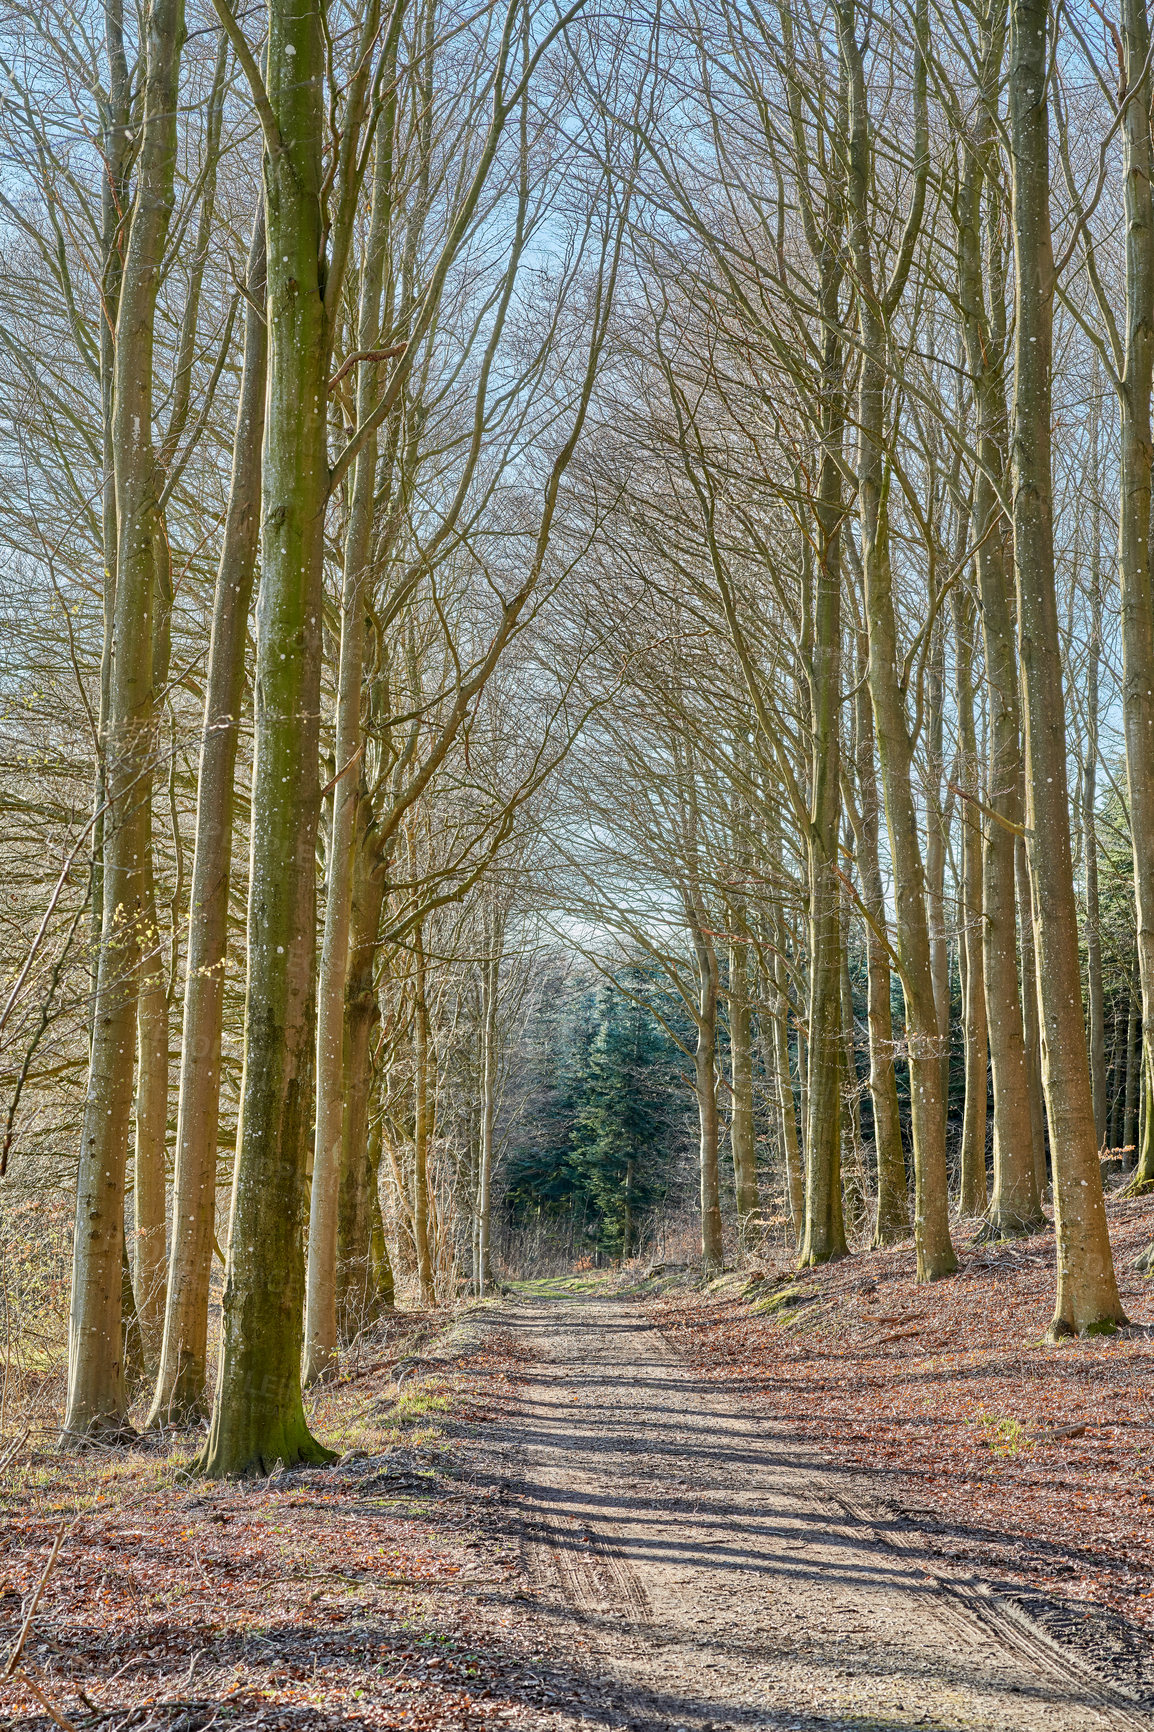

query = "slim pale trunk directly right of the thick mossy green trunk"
(305, 125), (393, 1384)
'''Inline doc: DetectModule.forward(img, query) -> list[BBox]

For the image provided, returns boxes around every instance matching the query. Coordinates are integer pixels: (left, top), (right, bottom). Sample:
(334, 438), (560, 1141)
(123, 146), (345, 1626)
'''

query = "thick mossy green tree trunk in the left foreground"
(201, 0), (340, 1476)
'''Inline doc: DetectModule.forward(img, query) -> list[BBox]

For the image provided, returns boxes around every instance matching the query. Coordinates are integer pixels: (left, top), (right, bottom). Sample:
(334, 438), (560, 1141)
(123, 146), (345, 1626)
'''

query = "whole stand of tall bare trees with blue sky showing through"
(0, 0), (1154, 1725)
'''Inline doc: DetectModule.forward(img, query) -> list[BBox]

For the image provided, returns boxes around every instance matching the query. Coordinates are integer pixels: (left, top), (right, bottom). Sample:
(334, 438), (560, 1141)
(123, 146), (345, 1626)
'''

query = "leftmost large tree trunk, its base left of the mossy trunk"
(64, 0), (184, 1441)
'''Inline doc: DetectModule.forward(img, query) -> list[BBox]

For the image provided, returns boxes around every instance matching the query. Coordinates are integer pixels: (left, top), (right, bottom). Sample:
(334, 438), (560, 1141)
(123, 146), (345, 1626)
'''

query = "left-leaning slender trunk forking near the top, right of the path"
(837, 0), (956, 1282)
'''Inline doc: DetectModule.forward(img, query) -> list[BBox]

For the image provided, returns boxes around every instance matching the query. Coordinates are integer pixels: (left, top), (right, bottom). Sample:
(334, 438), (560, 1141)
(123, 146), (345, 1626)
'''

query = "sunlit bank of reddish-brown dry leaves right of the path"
(655, 1199), (1154, 1632)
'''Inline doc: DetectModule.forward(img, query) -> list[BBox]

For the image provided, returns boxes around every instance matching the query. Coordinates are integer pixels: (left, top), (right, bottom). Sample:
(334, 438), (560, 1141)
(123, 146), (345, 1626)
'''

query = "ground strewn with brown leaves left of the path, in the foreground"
(0, 1320), (544, 1732)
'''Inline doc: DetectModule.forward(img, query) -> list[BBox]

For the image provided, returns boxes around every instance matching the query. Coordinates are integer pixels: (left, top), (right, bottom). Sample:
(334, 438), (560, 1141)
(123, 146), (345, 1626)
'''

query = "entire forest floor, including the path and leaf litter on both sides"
(0, 1207), (1154, 1732)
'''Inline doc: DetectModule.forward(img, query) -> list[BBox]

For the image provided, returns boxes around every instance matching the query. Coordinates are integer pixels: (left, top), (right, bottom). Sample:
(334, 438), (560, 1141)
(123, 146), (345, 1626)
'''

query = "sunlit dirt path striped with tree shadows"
(481, 1296), (1152, 1732)
